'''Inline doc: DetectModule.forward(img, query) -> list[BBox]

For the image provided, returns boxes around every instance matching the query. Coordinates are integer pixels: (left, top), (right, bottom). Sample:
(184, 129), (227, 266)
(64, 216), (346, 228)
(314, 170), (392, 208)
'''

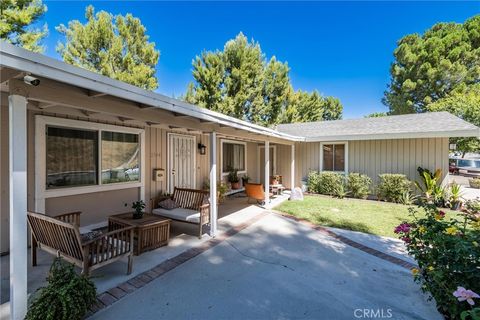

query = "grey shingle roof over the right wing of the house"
(277, 112), (480, 141)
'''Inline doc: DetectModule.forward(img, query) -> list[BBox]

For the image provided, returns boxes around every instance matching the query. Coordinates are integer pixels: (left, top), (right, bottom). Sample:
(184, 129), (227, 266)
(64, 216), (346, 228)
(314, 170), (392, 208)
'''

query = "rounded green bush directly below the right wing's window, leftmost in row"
(307, 171), (345, 198)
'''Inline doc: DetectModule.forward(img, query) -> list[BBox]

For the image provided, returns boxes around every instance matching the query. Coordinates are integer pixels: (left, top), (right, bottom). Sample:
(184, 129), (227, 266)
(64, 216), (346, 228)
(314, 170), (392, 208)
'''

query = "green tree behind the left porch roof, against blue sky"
(57, 6), (160, 90)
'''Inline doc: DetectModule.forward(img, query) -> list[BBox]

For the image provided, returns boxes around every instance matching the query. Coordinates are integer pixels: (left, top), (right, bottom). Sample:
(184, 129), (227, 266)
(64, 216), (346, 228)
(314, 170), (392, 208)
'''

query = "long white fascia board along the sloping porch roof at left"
(0, 41), (304, 141)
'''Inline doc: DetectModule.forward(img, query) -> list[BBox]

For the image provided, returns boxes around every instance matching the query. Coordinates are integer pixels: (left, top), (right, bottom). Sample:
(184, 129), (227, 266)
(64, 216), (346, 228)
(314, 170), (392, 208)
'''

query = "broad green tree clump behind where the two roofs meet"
(184, 33), (342, 126)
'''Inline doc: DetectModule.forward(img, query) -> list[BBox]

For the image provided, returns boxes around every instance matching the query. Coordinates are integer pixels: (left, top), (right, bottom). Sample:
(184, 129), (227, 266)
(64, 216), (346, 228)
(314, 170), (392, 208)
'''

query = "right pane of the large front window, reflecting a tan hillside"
(101, 131), (140, 184)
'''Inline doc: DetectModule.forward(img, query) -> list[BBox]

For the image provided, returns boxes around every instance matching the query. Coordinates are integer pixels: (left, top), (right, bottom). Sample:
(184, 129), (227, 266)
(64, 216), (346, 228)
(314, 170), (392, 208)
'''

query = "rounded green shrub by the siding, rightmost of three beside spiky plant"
(377, 173), (411, 203)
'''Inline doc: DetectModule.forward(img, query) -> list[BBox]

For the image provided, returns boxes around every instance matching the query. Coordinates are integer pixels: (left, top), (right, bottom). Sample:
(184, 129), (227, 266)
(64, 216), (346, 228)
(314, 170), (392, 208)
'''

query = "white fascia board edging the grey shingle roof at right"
(305, 128), (480, 142)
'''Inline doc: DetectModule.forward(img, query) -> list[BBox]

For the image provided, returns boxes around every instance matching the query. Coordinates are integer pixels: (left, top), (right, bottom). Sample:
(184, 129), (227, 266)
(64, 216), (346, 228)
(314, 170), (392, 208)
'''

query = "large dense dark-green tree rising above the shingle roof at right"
(383, 15), (480, 114)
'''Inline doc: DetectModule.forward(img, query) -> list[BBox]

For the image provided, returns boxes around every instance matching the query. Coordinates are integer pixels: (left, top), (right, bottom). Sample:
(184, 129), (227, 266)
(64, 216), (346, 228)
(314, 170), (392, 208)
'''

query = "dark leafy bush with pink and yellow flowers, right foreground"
(394, 204), (480, 319)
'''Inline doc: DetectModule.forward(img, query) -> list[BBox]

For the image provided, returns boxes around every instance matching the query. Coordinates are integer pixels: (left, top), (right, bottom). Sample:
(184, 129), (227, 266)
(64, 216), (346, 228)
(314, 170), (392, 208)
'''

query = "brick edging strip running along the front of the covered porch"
(86, 211), (270, 318)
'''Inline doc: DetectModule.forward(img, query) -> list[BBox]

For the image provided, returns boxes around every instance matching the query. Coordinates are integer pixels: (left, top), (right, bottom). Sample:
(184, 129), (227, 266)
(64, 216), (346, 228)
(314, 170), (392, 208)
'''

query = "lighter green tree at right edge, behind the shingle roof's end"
(427, 83), (480, 155)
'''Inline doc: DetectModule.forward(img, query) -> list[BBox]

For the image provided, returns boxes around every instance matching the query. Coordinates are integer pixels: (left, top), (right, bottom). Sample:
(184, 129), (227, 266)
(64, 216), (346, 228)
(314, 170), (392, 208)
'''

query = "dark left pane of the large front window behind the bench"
(46, 126), (98, 189)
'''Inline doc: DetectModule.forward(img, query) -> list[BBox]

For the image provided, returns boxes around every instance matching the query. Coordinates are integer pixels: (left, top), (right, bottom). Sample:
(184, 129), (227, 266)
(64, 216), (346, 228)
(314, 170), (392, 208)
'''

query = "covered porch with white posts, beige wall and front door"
(0, 43), (300, 319)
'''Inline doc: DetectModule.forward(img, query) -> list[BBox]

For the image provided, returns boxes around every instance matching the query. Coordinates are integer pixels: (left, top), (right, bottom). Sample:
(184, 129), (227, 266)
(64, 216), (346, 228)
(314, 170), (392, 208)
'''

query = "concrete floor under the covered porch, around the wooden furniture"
(0, 192), (289, 320)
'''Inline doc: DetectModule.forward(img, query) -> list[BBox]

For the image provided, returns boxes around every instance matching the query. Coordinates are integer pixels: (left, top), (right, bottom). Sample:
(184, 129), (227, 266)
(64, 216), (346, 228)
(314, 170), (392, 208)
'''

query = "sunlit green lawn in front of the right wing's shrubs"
(275, 196), (463, 238)
